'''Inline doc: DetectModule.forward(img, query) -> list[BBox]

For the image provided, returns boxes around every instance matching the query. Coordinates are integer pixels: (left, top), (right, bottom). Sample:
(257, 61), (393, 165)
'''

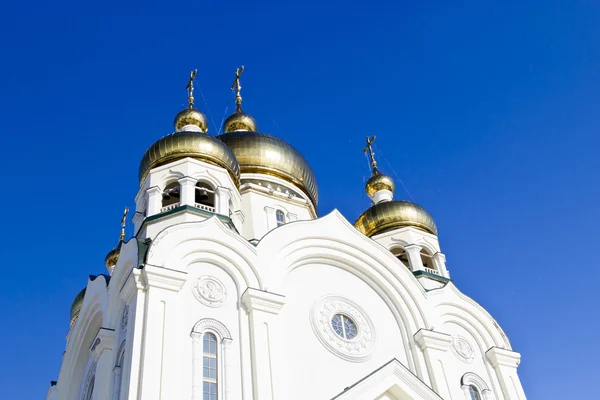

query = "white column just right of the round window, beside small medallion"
(414, 329), (452, 399)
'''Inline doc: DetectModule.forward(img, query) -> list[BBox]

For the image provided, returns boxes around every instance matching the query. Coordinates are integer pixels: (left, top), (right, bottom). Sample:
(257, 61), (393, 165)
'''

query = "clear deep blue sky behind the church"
(0, 0), (600, 399)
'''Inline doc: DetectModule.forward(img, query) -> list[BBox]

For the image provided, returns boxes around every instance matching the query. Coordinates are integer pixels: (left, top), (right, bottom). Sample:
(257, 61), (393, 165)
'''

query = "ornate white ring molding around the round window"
(310, 295), (377, 362)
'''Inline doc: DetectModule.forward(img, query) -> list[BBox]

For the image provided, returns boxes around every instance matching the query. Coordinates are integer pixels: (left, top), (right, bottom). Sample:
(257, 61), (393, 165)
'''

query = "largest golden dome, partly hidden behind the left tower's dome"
(218, 132), (319, 208)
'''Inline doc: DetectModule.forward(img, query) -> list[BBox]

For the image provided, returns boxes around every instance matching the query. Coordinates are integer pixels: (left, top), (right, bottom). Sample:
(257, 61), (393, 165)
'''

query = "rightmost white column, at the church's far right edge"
(485, 347), (526, 400)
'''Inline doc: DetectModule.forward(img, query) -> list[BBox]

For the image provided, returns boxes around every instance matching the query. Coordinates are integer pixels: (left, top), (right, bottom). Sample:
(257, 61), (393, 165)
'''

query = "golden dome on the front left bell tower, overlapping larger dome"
(139, 131), (240, 185)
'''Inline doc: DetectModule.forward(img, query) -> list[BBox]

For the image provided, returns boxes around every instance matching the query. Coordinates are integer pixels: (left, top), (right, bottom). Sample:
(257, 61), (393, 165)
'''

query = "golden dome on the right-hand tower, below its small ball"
(354, 200), (437, 237)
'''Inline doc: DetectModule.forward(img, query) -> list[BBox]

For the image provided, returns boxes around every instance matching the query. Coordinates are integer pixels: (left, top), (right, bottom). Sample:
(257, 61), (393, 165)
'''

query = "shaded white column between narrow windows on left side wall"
(92, 328), (115, 399)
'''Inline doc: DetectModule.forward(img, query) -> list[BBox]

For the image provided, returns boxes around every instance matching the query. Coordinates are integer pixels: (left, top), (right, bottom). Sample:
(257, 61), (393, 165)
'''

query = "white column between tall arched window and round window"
(242, 288), (285, 400)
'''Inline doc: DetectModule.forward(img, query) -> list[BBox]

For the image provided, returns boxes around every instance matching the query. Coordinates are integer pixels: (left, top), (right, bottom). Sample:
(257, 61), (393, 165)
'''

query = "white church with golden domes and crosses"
(46, 67), (526, 400)
